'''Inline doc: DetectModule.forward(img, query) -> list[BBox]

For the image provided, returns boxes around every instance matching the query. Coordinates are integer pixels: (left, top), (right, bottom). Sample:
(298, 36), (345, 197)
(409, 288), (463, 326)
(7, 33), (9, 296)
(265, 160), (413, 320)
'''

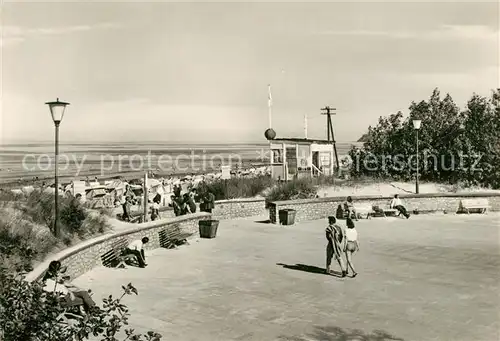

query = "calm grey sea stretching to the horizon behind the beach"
(0, 142), (360, 183)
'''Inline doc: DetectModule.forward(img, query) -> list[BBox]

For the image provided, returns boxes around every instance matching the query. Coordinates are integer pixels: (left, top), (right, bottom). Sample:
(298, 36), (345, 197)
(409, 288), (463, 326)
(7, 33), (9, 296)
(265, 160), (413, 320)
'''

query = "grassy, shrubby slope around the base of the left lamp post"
(0, 191), (110, 266)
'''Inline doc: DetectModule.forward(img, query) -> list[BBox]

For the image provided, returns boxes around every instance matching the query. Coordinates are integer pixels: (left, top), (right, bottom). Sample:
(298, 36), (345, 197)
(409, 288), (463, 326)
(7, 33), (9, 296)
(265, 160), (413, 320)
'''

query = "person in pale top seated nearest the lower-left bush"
(42, 261), (96, 313)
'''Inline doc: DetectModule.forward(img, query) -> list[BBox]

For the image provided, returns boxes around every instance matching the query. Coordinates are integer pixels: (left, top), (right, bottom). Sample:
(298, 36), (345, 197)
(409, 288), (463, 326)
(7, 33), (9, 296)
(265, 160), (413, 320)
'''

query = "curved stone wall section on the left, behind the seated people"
(26, 212), (211, 281)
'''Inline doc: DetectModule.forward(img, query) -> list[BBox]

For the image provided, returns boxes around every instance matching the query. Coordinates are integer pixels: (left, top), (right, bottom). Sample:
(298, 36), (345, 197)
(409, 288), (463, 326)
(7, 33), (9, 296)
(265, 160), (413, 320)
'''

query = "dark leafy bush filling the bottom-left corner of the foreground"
(0, 255), (161, 341)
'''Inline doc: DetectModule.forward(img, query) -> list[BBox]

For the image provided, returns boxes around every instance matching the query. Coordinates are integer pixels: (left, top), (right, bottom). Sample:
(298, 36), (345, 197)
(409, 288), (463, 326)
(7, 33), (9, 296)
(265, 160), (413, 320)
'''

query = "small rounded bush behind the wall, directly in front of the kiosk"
(266, 178), (317, 201)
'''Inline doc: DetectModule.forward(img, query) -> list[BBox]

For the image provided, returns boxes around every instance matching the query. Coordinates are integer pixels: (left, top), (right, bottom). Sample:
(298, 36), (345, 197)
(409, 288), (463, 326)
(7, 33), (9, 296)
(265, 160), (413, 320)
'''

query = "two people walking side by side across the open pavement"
(325, 216), (359, 277)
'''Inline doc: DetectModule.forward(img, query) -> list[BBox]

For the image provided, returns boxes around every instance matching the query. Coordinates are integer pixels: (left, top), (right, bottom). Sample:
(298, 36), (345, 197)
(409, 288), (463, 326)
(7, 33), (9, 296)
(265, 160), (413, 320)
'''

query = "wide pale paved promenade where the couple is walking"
(75, 213), (500, 341)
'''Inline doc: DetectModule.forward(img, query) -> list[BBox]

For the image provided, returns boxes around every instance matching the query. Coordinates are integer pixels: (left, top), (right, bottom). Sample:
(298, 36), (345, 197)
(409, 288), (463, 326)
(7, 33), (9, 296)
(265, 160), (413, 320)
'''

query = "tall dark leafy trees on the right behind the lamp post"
(349, 89), (500, 188)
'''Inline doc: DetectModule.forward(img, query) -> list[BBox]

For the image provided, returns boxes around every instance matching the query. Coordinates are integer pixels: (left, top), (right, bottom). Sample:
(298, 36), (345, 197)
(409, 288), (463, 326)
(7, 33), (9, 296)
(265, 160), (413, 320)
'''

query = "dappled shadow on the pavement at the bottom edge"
(278, 326), (404, 341)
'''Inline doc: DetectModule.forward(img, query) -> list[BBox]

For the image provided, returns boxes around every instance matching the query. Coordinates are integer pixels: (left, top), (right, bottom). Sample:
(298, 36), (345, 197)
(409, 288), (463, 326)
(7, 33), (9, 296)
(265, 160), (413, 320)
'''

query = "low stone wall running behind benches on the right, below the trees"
(269, 193), (500, 224)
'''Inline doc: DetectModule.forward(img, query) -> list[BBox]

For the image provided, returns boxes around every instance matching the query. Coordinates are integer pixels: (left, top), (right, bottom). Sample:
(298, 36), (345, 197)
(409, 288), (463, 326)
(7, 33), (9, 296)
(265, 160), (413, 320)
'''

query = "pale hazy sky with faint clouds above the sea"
(0, 1), (500, 143)
